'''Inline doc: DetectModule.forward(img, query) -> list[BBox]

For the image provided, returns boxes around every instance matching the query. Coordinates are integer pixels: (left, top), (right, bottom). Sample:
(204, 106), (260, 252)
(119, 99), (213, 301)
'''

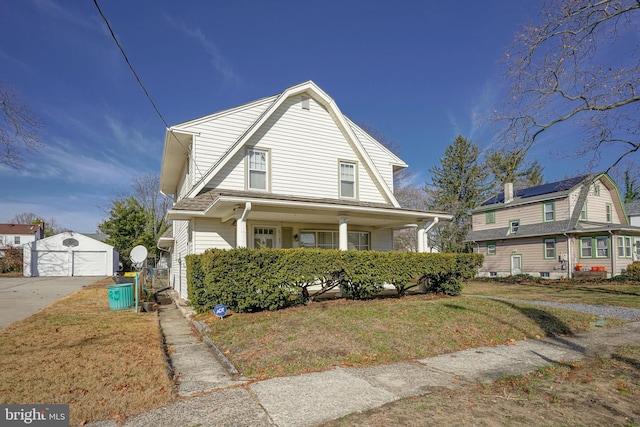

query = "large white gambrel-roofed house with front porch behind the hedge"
(158, 81), (451, 298)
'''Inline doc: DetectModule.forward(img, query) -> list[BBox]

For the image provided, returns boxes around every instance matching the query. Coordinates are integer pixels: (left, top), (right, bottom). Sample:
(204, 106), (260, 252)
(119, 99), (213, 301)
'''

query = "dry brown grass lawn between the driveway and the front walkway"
(0, 279), (174, 425)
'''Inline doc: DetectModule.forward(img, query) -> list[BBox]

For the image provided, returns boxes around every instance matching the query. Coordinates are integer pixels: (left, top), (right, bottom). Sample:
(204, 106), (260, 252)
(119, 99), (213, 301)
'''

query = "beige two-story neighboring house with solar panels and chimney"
(466, 174), (640, 278)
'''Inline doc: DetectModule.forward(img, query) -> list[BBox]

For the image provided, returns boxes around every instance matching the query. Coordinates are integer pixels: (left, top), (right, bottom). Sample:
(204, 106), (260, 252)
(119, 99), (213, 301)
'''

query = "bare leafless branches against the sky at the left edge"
(0, 80), (42, 169)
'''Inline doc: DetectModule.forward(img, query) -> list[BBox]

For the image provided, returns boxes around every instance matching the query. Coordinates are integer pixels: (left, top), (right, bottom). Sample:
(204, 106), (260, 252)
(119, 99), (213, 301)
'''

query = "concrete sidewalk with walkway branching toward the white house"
(90, 300), (640, 427)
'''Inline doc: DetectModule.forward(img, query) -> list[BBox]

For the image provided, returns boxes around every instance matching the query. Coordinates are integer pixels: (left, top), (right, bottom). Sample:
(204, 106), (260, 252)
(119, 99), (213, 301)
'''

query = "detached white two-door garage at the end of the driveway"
(23, 231), (119, 277)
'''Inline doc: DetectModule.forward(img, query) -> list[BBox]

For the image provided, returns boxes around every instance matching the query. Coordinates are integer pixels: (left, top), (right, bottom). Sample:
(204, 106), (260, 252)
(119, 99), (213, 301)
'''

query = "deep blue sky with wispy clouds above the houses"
(0, 0), (608, 233)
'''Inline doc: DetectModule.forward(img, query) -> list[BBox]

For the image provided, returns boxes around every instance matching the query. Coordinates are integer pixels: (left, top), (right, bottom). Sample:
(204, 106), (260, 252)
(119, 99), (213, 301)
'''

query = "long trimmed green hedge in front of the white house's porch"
(186, 249), (483, 312)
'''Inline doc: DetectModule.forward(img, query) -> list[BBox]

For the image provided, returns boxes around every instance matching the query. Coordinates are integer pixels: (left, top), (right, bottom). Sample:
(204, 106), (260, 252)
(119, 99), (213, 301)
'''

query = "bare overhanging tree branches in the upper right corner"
(496, 0), (640, 172)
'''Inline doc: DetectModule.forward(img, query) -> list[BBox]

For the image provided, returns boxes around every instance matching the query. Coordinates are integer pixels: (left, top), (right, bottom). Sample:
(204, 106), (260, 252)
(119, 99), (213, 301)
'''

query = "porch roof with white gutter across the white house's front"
(167, 189), (451, 228)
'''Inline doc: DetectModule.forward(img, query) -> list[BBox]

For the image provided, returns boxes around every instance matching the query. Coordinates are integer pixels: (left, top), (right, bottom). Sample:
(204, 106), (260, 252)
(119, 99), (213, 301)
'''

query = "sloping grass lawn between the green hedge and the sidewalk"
(200, 295), (621, 379)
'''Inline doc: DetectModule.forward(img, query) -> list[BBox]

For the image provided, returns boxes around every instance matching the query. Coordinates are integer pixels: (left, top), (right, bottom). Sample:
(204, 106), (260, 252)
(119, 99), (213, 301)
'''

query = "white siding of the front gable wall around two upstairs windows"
(207, 96), (389, 203)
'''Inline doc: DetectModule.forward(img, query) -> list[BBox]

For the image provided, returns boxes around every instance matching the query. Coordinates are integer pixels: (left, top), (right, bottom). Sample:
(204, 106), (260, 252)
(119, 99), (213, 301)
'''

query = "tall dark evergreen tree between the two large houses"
(425, 135), (488, 252)
